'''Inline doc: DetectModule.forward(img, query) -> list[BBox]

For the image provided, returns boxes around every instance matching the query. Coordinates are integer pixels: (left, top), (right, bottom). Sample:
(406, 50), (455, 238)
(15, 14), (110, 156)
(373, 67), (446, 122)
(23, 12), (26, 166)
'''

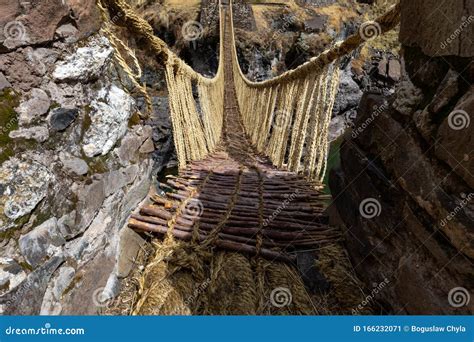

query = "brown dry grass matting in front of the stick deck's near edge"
(107, 234), (364, 315)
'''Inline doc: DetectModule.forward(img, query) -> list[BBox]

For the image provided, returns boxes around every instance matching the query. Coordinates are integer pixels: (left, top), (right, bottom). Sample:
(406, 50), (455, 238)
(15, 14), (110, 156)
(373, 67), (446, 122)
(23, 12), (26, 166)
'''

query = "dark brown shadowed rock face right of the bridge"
(330, 0), (474, 314)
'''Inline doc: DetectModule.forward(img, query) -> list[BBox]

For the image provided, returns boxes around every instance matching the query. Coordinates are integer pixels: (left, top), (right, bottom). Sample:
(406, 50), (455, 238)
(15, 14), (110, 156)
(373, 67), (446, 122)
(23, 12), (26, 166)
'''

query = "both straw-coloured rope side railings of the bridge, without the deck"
(99, 0), (400, 181)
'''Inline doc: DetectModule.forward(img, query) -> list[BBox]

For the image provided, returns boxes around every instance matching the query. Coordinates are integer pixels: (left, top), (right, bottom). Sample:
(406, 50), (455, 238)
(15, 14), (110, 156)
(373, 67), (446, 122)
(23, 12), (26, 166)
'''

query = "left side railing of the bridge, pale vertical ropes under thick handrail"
(97, 0), (224, 168)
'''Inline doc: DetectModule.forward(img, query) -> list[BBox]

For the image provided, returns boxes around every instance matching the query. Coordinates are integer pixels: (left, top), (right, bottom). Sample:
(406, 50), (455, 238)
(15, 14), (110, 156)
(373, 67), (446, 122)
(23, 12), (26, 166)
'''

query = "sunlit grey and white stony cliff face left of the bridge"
(0, 0), (170, 314)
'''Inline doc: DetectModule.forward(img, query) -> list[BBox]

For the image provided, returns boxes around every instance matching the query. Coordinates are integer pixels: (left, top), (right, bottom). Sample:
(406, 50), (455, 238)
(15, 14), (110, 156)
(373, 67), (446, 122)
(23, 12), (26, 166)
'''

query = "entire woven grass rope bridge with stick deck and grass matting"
(99, 0), (400, 314)
